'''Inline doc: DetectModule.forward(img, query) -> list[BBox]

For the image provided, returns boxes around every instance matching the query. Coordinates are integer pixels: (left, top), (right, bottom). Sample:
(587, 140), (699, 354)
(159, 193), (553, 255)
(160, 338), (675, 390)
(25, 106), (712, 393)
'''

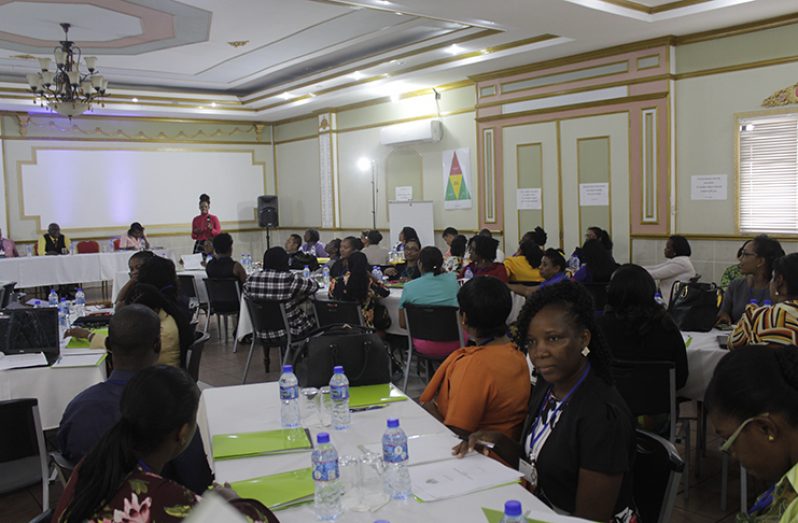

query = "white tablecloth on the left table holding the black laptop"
(0, 363), (105, 430)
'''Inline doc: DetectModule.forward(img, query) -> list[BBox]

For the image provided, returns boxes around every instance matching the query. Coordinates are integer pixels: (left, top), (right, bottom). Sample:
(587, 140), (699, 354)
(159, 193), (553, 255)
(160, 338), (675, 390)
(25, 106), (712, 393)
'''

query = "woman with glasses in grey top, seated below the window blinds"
(716, 234), (784, 325)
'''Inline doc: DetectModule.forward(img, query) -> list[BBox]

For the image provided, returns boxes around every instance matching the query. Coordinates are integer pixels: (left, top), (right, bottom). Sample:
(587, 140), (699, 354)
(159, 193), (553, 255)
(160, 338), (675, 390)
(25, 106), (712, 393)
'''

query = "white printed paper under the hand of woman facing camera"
(408, 454), (522, 501)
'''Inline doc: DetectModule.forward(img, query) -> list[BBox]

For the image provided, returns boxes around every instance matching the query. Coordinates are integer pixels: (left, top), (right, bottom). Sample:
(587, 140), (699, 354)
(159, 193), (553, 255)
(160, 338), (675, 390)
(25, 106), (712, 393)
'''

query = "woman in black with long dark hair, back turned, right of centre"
(597, 263), (688, 389)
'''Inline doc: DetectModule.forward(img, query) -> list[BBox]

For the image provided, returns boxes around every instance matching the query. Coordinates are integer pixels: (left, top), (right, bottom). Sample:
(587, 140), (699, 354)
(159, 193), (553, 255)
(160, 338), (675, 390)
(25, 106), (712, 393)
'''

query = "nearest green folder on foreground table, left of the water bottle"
(230, 468), (313, 510)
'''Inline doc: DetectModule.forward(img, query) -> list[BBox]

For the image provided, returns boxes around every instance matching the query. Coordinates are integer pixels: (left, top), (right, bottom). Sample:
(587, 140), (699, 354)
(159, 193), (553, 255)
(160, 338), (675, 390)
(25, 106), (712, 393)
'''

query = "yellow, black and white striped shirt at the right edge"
(729, 300), (798, 349)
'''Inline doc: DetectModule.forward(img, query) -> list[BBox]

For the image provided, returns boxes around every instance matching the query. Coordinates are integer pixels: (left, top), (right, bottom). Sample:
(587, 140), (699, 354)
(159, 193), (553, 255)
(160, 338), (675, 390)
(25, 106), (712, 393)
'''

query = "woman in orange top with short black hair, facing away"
(420, 276), (531, 440)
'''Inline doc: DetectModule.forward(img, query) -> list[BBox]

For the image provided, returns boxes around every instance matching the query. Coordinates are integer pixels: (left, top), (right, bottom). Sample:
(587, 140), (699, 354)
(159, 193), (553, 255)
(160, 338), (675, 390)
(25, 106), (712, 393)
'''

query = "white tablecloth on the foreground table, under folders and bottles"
(197, 382), (576, 523)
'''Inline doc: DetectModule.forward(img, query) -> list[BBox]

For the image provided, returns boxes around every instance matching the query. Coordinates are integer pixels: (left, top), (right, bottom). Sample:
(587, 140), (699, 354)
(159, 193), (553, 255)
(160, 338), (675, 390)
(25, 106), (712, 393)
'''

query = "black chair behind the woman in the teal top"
(402, 304), (465, 391)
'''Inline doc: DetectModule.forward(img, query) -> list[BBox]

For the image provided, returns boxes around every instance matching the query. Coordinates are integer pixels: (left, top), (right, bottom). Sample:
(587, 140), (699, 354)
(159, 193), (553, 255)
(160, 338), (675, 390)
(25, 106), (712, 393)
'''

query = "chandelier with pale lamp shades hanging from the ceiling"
(27, 23), (108, 119)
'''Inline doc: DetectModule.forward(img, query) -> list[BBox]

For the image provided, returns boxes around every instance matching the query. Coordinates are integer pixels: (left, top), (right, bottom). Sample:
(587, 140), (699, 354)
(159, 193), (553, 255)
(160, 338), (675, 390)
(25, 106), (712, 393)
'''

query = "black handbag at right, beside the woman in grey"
(668, 281), (721, 332)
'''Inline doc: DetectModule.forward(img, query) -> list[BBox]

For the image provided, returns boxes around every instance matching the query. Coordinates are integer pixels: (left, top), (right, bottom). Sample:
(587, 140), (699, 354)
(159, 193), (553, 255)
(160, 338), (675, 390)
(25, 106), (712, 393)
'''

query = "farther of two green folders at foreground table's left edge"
(211, 428), (313, 459)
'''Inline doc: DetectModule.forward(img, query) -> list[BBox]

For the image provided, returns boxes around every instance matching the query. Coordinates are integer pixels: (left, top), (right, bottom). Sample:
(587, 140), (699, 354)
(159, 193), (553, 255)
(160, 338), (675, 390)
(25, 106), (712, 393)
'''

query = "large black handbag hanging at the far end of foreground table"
(293, 323), (391, 387)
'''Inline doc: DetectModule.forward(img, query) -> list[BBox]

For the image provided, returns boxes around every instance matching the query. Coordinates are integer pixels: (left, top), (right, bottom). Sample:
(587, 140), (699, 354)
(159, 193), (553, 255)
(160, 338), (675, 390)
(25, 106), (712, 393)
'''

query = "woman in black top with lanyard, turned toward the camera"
(456, 282), (636, 522)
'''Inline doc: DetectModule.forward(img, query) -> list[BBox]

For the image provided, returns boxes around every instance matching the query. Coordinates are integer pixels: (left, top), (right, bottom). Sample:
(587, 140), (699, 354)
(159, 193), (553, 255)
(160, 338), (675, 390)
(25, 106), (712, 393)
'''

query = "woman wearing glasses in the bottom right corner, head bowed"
(704, 346), (798, 523)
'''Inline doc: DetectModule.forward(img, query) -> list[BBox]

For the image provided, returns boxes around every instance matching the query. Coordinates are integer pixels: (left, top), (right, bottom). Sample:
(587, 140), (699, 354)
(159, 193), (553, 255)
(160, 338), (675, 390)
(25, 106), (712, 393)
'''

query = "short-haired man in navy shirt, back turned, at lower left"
(58, 304), (213, 494)
